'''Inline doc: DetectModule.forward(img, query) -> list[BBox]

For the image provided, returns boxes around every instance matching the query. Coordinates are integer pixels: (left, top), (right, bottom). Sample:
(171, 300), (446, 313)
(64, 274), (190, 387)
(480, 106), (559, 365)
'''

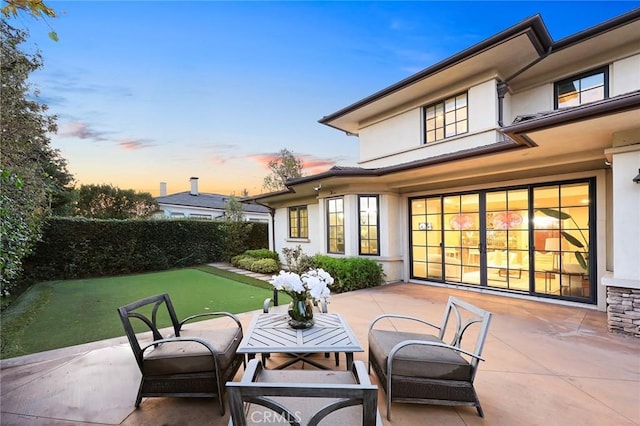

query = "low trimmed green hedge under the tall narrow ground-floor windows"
(311, 254), (385, 293)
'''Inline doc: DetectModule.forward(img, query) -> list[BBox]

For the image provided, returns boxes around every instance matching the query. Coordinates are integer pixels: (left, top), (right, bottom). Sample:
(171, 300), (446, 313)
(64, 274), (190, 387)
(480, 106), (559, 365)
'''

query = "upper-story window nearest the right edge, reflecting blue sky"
(554, 67), (609, 109)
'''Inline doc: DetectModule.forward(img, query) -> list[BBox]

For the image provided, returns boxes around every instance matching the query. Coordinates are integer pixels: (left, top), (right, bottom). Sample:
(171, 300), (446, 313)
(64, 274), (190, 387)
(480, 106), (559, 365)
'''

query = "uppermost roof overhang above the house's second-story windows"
(319, 9), (640, 134)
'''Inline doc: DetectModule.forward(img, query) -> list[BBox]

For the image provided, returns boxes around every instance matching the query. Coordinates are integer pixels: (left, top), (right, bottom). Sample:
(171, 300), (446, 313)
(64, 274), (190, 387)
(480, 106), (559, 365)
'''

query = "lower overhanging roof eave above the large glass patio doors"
(245, 91), (640, 204)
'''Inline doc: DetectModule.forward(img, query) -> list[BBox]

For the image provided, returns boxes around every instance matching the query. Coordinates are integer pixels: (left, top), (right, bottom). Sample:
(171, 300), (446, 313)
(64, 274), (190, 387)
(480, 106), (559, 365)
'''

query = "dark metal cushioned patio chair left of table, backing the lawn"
(118, 293), (244, 415)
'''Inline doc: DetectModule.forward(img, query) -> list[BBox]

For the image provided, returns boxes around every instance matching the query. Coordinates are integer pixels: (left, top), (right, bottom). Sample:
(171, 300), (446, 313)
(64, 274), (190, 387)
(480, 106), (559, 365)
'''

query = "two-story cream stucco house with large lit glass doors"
(247, 9), (640, 336)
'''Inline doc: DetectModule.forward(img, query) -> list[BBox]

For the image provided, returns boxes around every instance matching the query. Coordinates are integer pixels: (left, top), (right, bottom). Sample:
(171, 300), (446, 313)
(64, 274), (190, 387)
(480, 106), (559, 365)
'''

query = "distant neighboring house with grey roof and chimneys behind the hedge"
(156, 177), (270, 222)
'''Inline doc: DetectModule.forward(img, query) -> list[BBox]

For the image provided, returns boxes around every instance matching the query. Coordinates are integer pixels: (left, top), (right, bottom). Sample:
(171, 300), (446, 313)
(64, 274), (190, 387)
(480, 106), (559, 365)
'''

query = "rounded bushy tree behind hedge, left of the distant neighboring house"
(75, 184), (158, 219)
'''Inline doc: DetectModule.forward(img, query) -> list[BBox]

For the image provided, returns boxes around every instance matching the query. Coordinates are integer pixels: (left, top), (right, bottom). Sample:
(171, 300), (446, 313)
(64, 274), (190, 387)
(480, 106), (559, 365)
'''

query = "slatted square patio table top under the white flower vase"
(237, 313), (364, 354)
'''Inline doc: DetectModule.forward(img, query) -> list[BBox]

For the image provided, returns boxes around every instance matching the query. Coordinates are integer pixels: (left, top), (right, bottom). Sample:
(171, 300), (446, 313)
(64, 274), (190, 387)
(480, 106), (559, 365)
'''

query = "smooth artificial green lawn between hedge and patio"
(2, 266), (286, 358)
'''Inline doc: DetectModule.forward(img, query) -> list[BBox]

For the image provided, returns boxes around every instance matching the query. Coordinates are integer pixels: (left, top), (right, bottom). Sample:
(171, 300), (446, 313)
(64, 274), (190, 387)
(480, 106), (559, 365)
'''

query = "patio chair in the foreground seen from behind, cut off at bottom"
(227, 359), (382, 426)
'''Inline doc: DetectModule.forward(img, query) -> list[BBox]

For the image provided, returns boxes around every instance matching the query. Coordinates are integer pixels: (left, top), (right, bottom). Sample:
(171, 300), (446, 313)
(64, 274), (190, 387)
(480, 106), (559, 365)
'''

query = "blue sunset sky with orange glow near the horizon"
(10, 0), (640, 196)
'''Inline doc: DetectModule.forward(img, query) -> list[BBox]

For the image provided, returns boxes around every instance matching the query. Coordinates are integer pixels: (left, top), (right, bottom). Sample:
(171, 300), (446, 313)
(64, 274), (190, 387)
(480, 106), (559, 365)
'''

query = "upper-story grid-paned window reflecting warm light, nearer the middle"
(424, 93), (469, 143)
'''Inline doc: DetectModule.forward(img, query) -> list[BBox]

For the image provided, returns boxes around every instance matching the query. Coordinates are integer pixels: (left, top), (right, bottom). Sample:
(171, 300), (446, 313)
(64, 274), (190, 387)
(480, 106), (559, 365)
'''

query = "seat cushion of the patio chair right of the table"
(369, 329), (471, 381)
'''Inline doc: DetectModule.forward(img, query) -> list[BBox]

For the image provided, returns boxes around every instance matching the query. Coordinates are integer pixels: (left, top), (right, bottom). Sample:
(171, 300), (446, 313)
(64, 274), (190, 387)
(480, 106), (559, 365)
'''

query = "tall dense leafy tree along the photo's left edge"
(0, 20), (73, 294)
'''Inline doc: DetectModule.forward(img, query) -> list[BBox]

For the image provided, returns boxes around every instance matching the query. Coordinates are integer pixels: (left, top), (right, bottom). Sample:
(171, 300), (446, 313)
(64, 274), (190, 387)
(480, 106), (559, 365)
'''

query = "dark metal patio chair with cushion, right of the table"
(369, 297), (491, 420)
